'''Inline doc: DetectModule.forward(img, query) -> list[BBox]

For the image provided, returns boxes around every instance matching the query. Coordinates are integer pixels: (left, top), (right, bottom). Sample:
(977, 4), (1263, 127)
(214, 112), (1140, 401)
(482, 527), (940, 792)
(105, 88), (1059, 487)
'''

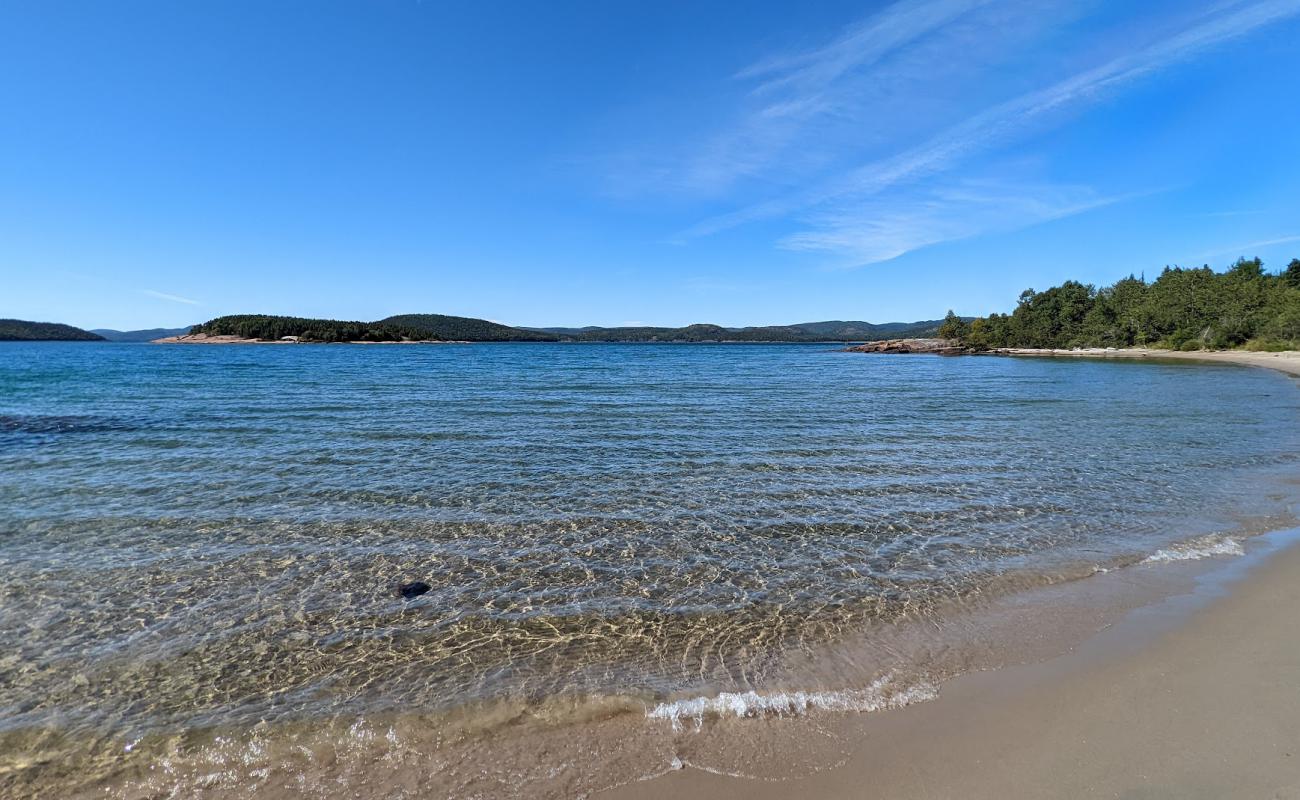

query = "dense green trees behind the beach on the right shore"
(939, 259), (1300, 350)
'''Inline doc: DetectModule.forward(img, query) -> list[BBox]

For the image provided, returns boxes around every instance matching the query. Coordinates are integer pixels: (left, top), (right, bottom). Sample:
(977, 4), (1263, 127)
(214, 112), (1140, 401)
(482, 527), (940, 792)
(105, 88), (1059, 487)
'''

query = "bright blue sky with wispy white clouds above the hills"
(0, 0), (1300, 328)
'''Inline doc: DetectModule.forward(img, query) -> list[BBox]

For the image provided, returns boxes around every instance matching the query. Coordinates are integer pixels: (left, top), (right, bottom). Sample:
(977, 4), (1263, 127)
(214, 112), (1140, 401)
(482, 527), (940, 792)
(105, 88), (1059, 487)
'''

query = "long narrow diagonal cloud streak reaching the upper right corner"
(677, 0), (1300, 244)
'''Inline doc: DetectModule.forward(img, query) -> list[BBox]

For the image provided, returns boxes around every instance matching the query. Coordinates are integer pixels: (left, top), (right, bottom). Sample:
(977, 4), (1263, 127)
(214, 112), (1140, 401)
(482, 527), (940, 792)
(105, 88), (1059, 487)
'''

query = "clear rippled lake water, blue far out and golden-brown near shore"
(0, 343), (1300, 787)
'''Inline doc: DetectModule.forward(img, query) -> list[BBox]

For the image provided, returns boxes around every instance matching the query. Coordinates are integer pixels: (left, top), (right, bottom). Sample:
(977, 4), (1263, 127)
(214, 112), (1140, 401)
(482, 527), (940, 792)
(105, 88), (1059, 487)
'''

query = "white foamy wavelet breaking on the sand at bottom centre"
(646, 675), (939, 731)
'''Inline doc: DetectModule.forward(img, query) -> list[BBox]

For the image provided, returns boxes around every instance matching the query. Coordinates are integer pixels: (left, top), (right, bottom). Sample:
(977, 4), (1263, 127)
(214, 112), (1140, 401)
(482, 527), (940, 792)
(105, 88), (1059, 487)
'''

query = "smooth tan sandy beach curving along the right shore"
(601, 350), (1300, 800)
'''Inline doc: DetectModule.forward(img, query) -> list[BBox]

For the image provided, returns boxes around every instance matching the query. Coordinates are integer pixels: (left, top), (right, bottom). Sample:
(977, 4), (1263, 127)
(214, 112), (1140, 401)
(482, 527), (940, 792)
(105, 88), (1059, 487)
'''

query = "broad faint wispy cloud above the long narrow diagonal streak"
(670, 0), (1055, 194)
